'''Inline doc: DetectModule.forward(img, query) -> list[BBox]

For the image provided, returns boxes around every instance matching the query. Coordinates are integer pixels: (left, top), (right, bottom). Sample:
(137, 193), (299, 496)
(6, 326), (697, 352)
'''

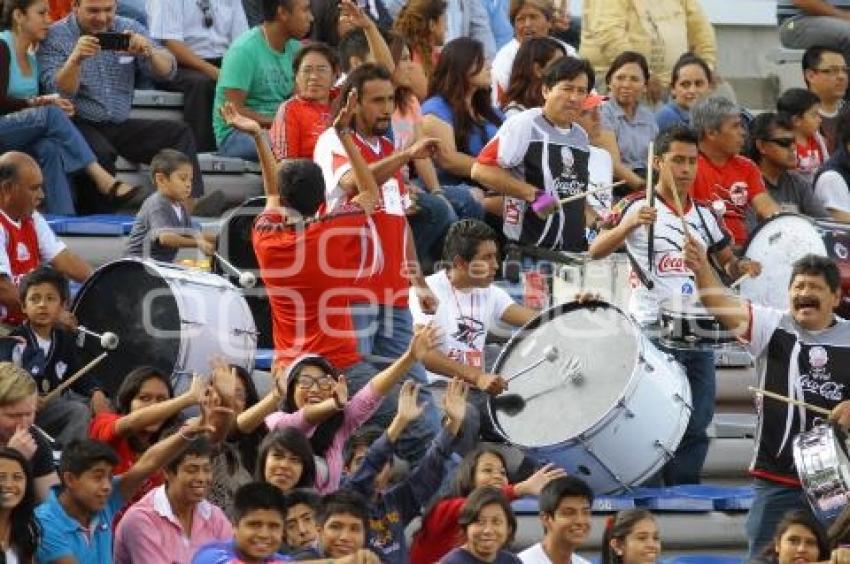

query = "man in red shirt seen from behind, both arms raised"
(222, 94), (432, 460)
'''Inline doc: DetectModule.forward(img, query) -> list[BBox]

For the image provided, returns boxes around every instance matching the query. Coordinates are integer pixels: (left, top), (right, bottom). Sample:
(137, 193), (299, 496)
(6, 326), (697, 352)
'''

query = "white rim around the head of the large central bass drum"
(487, 300), (640, 449)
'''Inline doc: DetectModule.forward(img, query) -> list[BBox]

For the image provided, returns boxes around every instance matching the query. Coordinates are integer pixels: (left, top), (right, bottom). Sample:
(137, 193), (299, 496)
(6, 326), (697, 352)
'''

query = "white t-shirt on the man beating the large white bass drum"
(410, 270), (514, 382)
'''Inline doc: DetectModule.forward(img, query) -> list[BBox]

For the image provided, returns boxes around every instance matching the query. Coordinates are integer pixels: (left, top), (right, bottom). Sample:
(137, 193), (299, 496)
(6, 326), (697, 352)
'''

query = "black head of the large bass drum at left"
(72, 259), (181, 399)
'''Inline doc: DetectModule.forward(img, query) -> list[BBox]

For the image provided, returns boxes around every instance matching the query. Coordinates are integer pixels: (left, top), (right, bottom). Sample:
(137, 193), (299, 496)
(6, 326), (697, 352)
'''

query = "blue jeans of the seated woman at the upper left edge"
(0, 106), (95, 215)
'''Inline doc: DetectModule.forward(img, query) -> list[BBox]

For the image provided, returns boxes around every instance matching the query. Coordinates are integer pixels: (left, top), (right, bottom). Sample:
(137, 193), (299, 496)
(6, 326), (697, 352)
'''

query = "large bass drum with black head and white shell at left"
(72, 258), (257, 398)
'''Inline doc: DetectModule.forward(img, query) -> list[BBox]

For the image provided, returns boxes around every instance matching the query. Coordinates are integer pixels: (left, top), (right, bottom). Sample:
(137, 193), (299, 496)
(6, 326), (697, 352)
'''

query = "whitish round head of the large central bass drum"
(491, 302), (639, 447)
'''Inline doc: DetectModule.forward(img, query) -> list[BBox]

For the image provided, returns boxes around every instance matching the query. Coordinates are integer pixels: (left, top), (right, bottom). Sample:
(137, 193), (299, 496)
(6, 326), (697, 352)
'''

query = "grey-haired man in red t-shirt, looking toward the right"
(691, 98), (779, 247)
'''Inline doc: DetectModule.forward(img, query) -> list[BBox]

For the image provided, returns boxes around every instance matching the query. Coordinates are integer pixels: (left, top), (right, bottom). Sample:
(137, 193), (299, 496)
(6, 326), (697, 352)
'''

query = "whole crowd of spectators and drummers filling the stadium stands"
(0, 0), (850, 564)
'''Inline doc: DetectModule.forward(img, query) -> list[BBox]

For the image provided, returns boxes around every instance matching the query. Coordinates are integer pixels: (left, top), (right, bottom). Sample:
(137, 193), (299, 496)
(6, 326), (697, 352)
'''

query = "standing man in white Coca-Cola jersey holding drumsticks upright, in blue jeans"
(589, 127), (760, 485)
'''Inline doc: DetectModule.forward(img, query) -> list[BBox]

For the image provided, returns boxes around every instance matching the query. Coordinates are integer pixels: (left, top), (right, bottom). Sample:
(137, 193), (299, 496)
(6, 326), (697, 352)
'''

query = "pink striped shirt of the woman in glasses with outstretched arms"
(266, 382), (384, 494)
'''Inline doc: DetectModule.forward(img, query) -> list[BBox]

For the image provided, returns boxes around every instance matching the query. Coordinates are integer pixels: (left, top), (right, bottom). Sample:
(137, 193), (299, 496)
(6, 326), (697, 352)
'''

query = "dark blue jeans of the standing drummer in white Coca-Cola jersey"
(653, 339), (717, 486)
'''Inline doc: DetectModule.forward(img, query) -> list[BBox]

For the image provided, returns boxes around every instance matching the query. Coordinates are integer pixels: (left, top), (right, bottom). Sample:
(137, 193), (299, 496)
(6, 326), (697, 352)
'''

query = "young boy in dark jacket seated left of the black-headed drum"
(0, 266), (109, 445)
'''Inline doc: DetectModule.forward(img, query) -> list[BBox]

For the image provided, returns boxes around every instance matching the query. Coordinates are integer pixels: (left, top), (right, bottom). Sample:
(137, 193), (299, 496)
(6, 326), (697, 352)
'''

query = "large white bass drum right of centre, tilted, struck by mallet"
(490, 302), (691, 494)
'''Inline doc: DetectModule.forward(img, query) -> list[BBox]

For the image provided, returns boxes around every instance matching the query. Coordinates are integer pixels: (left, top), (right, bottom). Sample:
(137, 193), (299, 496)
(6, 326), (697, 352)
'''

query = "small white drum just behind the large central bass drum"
(552, 253), (632, 310)
